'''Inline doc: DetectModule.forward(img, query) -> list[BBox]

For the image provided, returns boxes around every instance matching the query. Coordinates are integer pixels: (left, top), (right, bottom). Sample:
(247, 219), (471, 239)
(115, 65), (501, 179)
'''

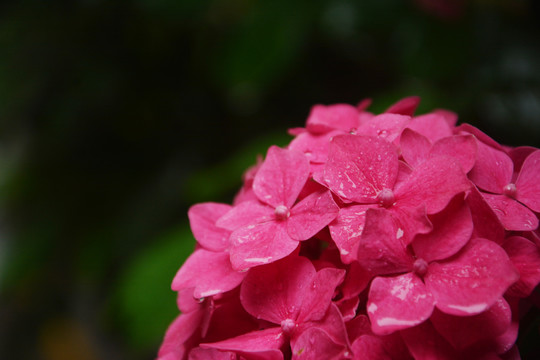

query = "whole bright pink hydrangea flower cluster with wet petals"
(158, 97), (540, 360)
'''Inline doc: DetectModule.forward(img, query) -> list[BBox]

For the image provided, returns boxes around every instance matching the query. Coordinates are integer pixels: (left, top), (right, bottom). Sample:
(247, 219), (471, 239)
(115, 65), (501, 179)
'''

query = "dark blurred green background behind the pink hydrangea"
(0, 0), (540, 360)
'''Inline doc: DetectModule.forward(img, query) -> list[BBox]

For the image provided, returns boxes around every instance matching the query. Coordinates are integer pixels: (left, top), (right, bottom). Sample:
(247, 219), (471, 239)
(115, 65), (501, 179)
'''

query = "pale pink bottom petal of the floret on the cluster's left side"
(230, 221), (298, 270)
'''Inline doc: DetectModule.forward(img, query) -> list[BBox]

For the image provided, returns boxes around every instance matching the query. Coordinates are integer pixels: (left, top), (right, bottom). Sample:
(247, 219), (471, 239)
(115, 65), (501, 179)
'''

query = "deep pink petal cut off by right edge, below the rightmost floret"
(503, 236), (540, 298)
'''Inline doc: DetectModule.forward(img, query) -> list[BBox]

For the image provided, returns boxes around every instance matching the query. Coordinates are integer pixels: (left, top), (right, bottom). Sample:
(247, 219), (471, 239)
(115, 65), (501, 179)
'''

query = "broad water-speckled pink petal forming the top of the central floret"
(324, 135), (398, 203)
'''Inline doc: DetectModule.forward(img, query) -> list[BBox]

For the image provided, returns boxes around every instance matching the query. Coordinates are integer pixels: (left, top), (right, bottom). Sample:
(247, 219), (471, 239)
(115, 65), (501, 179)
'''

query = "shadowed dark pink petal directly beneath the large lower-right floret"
(431, 298), (512, 350)
